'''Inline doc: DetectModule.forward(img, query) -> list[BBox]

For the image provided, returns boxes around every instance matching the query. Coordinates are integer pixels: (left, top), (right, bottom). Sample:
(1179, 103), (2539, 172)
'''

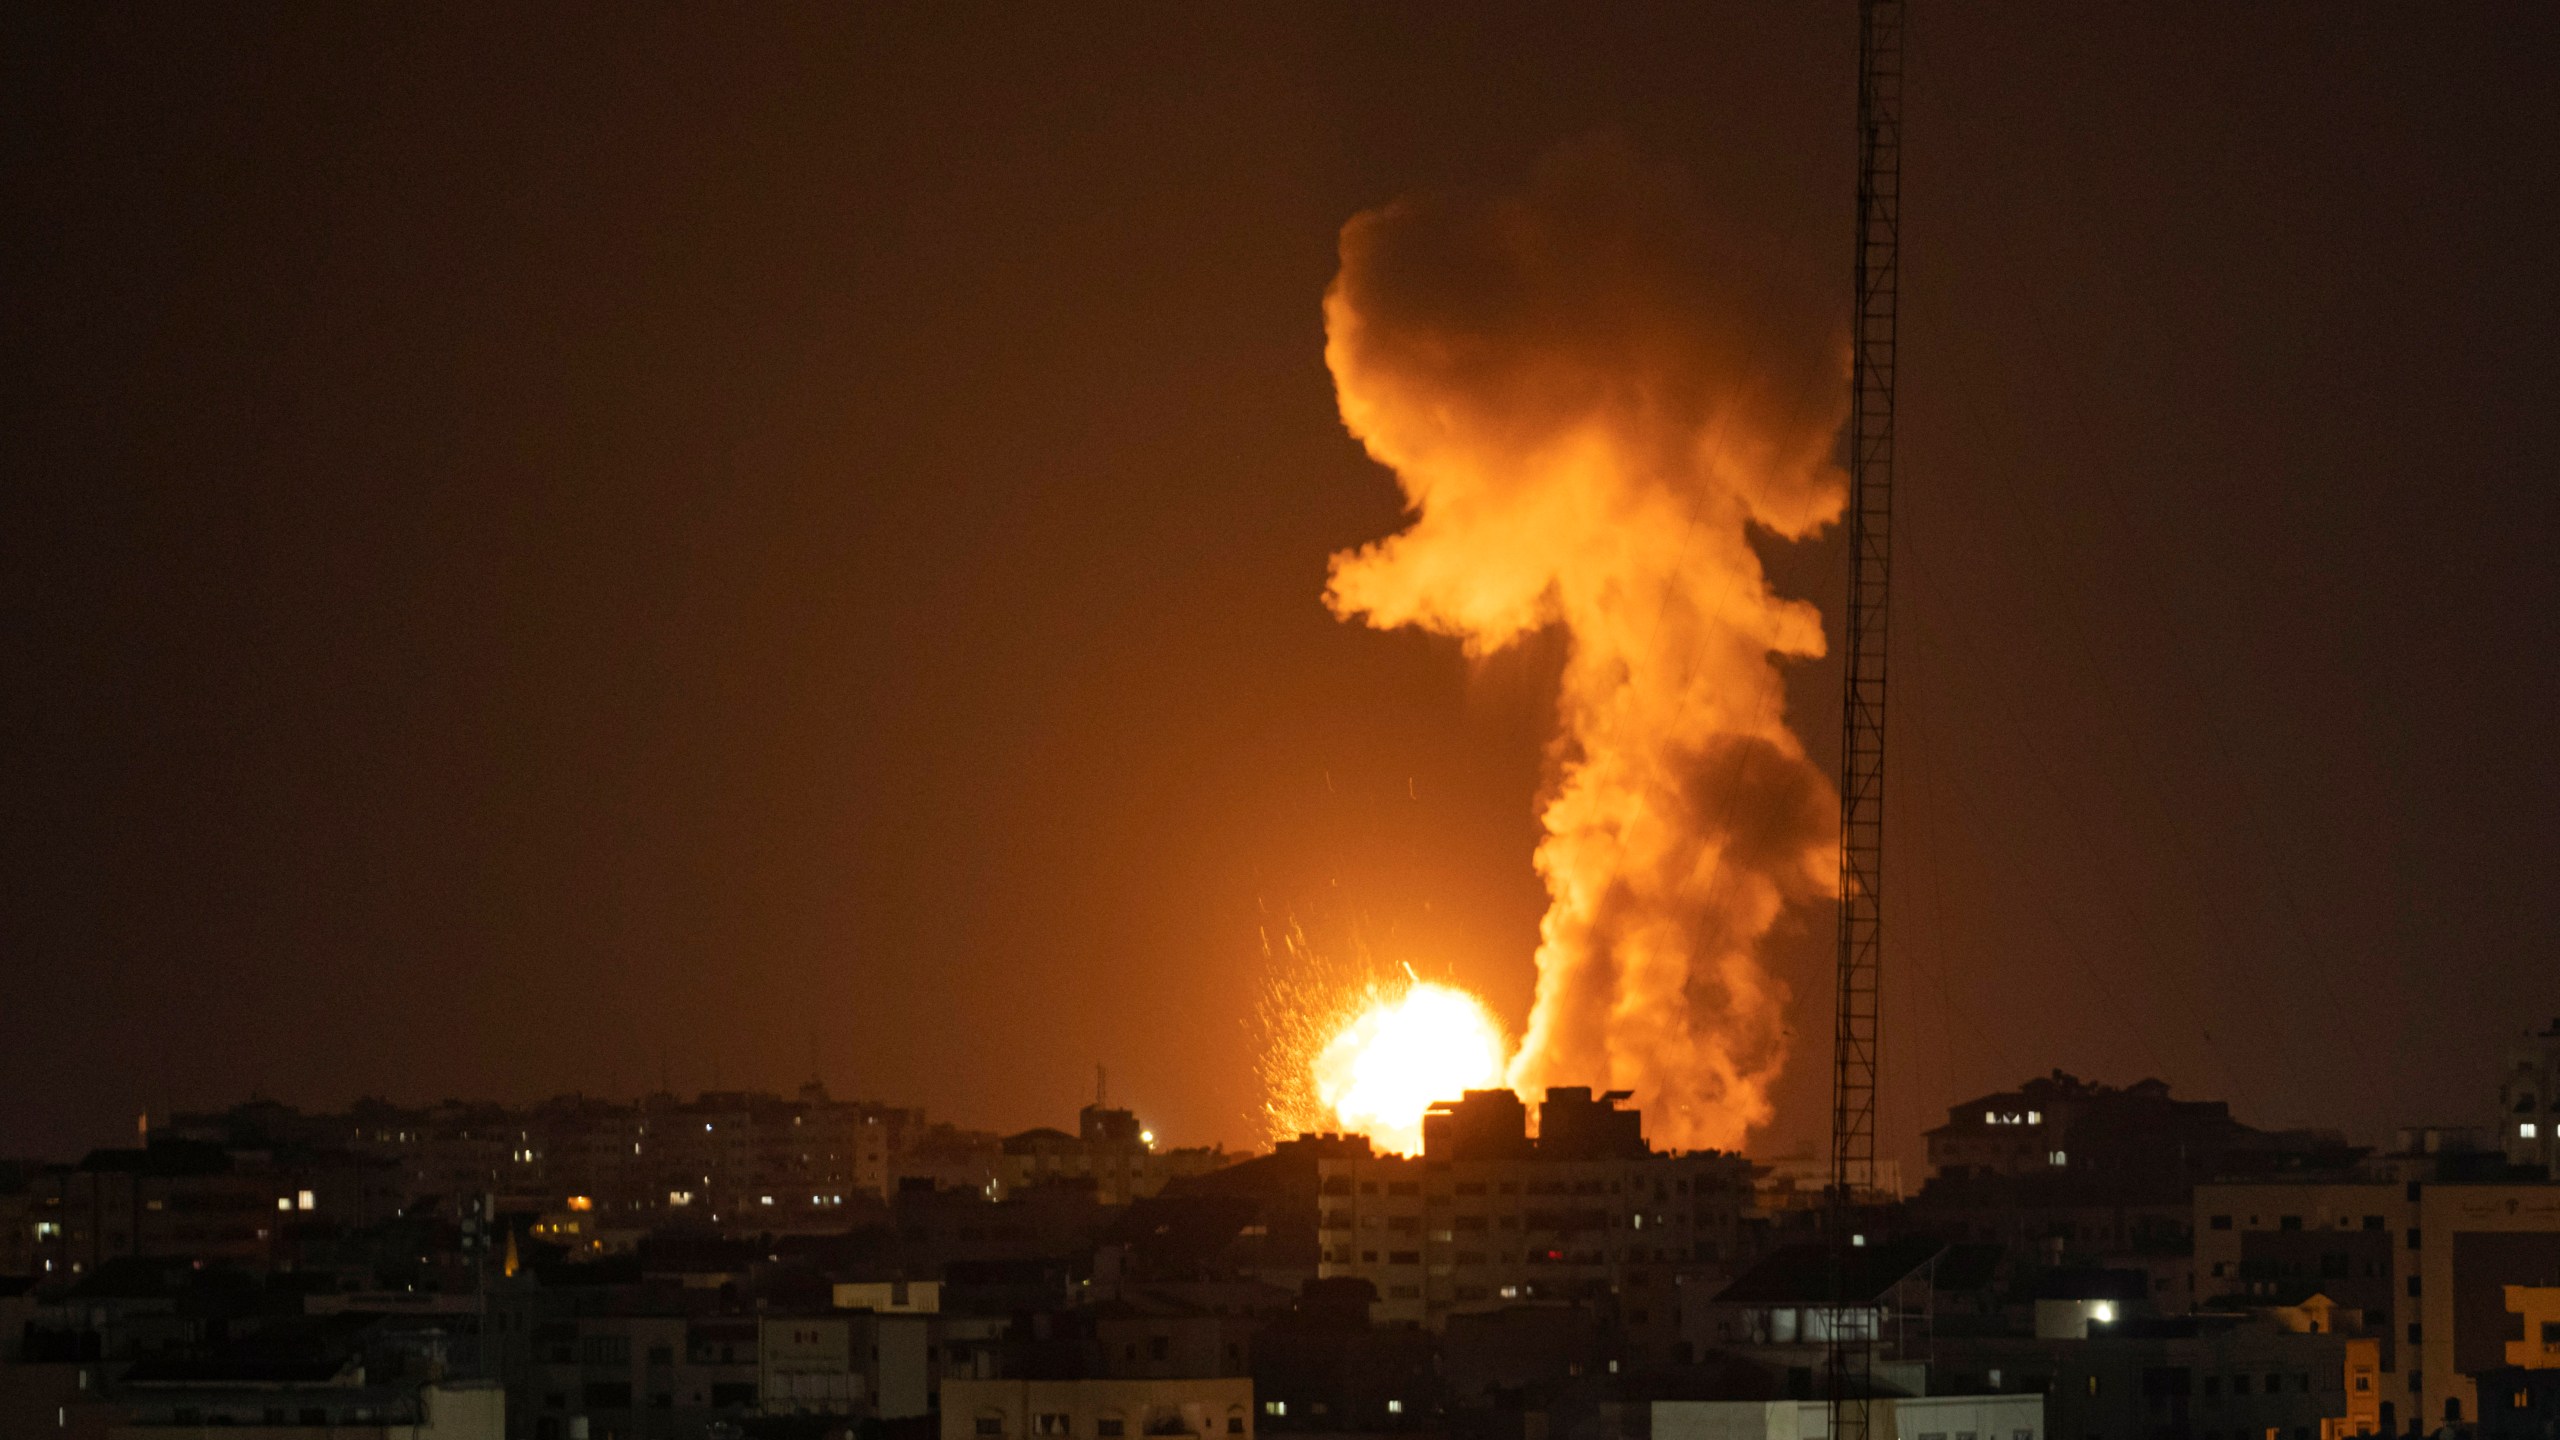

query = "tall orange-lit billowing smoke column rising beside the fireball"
(1324, 146), (1848, 1148)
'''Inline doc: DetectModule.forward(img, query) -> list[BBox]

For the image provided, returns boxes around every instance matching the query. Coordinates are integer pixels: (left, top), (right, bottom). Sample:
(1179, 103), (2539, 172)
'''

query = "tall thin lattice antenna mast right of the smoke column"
(1825, 0), (1902, 1440)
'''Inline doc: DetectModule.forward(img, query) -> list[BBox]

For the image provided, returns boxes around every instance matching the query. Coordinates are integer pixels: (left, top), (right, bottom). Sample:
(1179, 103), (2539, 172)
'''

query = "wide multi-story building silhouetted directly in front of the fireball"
(1316, 1086), (1751, 1348)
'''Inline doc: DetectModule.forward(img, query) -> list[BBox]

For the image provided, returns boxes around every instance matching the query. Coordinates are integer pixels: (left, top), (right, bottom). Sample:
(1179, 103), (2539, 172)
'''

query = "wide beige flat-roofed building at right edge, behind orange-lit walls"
(2196, 1179), (2560, 1432)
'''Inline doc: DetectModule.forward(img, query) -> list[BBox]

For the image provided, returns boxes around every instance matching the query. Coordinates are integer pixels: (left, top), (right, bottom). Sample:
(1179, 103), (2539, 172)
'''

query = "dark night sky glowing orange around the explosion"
(0, 0), (2560, 1153)
